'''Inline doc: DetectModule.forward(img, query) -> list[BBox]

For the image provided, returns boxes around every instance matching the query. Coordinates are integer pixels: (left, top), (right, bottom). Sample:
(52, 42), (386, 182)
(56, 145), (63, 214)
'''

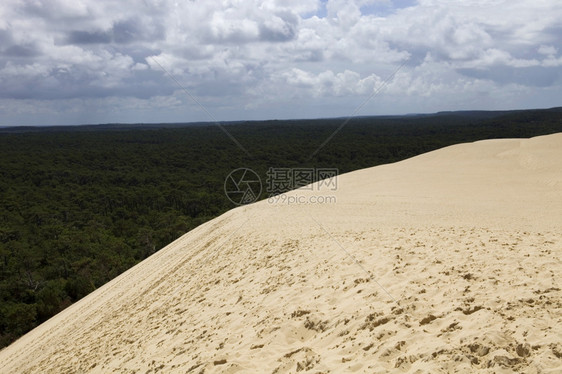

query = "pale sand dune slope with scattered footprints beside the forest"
(0, 134), (562, 373)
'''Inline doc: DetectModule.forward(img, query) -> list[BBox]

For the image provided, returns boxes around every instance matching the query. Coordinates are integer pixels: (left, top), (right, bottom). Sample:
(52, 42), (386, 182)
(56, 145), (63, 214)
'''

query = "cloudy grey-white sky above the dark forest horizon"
(0, 0), (562, 125)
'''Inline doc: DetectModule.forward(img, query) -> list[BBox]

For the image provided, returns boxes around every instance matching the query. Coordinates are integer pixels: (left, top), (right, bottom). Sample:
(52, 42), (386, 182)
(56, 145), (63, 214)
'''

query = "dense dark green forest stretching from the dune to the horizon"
(0, 110), (562, 347)
